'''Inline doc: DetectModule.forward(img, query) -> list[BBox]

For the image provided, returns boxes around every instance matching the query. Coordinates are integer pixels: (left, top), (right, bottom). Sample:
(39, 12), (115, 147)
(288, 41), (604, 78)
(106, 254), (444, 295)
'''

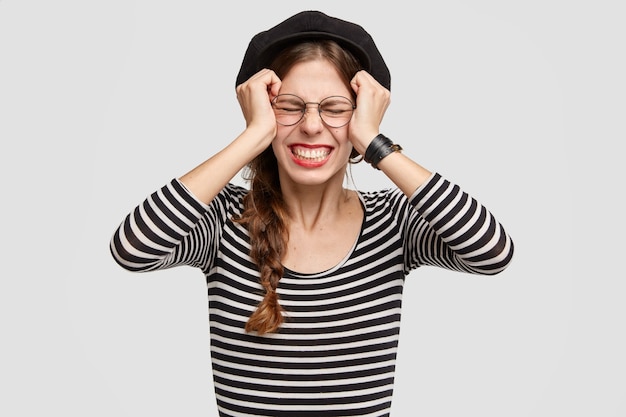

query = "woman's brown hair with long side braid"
(233, 40), (361, 334)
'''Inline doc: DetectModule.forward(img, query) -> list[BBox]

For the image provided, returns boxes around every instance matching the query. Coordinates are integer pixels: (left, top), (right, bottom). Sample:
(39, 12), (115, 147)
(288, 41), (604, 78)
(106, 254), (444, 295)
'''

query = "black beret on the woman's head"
(235, 11), (391, 89)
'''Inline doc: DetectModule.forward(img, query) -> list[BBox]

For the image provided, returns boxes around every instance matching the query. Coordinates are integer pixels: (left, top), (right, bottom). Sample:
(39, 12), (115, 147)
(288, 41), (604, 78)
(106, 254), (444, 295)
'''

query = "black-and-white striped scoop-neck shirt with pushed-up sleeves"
(110, 174), (513, 417)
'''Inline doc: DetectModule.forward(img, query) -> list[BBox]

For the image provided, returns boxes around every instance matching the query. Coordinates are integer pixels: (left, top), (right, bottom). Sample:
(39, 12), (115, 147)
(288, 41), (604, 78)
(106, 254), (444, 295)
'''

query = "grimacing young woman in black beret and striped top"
(111, 11), (513, 417)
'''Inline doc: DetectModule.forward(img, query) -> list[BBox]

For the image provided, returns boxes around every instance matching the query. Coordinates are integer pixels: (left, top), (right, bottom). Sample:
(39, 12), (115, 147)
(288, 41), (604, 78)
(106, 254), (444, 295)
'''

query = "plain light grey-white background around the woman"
(0, 0), (626, 417)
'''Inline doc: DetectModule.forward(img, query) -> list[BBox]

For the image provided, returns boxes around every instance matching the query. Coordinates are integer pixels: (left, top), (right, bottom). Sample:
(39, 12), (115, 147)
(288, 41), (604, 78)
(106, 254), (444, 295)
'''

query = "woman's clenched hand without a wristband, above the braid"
(236, 69), (281, 145)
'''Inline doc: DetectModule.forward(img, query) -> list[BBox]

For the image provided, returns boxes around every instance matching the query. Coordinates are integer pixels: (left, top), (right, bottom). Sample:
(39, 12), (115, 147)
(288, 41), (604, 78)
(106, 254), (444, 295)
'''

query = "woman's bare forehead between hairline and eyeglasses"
(280, 59), (350, 100)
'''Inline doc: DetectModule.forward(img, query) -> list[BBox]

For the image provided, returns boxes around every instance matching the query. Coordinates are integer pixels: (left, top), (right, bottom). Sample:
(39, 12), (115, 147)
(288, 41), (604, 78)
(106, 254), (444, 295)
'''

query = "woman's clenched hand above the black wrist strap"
(348, 71), (391, 155)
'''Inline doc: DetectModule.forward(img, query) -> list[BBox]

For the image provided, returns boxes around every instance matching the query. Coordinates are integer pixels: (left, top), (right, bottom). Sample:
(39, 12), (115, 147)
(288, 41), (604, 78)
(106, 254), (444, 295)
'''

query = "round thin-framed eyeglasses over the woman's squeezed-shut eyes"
(272, 94), (356, 128)
